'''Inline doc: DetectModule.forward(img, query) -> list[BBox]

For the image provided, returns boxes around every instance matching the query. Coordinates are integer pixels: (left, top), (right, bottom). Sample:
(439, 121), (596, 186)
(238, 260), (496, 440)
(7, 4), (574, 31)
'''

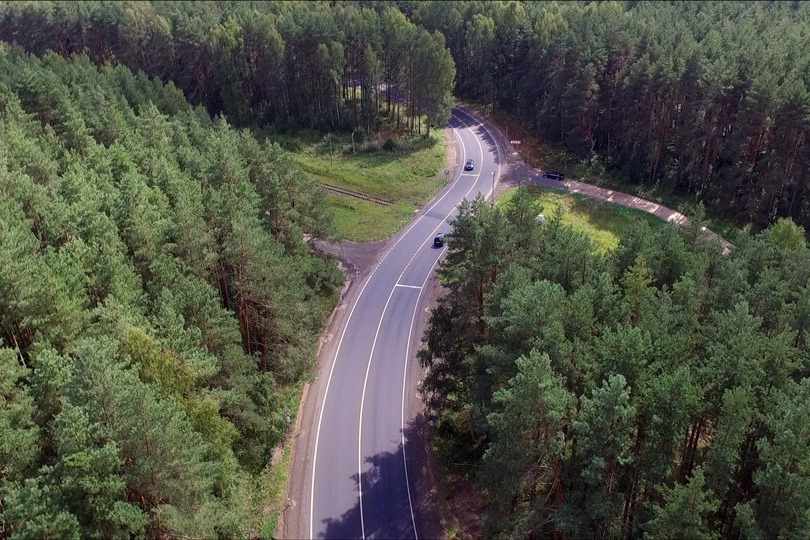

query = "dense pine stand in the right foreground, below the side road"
(420, 192), (810, 538)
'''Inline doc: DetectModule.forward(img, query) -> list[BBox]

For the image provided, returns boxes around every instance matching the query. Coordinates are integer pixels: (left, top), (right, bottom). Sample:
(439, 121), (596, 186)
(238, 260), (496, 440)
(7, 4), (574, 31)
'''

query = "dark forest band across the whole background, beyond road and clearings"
(0, 0), (810, 226)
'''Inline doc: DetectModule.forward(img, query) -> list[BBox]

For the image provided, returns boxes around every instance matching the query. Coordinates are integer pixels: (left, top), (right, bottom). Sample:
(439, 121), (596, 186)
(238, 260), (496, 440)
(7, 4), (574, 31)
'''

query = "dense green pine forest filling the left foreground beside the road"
(0, 45), (342, 538)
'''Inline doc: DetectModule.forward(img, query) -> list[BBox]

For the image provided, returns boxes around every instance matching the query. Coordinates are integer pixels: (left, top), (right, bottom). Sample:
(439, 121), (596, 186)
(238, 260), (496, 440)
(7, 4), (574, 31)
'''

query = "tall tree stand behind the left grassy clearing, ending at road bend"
(0, 1), (455, 132)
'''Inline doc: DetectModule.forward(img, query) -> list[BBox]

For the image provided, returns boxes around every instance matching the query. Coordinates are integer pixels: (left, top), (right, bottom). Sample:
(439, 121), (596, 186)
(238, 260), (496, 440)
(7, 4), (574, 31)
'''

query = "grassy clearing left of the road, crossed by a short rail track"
(273, 130), (449, 242)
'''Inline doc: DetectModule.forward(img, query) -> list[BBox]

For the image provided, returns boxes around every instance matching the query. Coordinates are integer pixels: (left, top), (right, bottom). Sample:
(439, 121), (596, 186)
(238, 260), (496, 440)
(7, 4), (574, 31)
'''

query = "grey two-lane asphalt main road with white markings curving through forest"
(299, 110), (501, 538)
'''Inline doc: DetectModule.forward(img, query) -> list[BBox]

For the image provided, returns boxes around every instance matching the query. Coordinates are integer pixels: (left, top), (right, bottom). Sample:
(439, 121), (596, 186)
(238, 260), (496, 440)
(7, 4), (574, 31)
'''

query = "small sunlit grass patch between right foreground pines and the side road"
(498, 186), (666, 253)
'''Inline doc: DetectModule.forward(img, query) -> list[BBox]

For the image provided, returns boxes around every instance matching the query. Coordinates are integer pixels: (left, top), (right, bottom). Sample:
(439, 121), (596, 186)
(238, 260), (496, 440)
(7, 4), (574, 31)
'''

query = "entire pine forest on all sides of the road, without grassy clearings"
(0, 0), (810, 539)
